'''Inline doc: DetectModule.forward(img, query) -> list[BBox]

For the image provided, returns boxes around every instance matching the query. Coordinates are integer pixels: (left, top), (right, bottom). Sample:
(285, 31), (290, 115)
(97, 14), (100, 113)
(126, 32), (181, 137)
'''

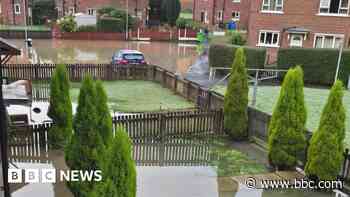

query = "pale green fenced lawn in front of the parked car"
(70, 81), (194, 112)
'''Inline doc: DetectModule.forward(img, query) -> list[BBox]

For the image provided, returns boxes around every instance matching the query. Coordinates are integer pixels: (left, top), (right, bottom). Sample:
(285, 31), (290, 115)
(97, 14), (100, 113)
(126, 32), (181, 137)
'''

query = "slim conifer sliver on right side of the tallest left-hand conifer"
(95, 81), (113, 147)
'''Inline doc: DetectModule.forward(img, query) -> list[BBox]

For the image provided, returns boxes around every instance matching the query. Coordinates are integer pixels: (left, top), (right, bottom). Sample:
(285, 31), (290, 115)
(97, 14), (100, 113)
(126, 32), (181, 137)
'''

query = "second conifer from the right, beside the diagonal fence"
(268, 66), (306, 169)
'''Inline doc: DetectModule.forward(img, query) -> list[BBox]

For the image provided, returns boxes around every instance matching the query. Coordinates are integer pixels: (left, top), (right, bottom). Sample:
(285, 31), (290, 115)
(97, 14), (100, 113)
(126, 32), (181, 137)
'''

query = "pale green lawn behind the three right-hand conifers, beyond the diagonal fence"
(215, 86), (350, 148)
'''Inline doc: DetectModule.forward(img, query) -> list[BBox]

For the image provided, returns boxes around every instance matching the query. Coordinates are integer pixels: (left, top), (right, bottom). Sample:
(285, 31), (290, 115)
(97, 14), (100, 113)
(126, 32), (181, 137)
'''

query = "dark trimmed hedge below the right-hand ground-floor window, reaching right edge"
(277, 48), (350, 85)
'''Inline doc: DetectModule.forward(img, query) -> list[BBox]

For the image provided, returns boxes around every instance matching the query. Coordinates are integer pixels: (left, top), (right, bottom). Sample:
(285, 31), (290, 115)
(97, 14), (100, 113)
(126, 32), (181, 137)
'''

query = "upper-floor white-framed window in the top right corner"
(320, 0), (349, 15)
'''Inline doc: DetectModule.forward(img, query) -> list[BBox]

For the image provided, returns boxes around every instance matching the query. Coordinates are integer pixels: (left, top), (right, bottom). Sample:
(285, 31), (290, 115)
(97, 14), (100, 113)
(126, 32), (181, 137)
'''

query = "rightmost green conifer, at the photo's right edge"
(305, 81), (346, 180)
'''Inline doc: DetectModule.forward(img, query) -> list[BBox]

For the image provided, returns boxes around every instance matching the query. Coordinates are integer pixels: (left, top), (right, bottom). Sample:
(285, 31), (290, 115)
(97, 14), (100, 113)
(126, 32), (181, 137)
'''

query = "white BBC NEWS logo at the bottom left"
(8, 169), (102, 183)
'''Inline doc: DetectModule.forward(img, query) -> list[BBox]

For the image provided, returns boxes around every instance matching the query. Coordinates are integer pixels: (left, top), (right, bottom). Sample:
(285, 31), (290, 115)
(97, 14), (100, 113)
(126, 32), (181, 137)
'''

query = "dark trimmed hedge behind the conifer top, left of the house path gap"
(209, 44), (266, 68)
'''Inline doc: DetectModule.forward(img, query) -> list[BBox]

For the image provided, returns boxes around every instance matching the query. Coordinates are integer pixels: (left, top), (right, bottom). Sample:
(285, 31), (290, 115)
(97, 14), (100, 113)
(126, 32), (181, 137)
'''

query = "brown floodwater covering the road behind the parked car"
(9, 40), (197, 73)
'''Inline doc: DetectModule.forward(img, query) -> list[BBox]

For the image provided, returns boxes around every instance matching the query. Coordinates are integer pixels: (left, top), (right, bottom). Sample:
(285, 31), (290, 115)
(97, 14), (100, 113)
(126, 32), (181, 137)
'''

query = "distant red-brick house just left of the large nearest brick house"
(193, 0), (250, 29)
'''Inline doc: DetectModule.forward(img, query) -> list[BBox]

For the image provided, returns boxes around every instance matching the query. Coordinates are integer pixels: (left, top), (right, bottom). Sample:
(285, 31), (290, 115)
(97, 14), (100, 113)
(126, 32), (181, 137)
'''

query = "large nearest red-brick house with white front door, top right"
(248, 0), (350, 63)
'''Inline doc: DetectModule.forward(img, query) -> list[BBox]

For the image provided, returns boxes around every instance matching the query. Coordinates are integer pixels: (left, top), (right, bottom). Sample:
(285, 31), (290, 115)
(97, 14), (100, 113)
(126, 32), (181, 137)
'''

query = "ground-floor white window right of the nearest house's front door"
(314, 34), (344, 48)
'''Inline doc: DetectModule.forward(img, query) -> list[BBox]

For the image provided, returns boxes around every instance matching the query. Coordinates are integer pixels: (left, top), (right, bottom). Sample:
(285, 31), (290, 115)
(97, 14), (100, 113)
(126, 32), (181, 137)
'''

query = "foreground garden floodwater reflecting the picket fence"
(6, 139), (331, 197)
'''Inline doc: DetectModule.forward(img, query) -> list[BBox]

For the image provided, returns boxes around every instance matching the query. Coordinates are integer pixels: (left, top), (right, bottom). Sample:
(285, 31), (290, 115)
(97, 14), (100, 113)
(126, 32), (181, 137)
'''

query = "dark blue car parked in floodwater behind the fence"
(112, 49), (147, 65)
